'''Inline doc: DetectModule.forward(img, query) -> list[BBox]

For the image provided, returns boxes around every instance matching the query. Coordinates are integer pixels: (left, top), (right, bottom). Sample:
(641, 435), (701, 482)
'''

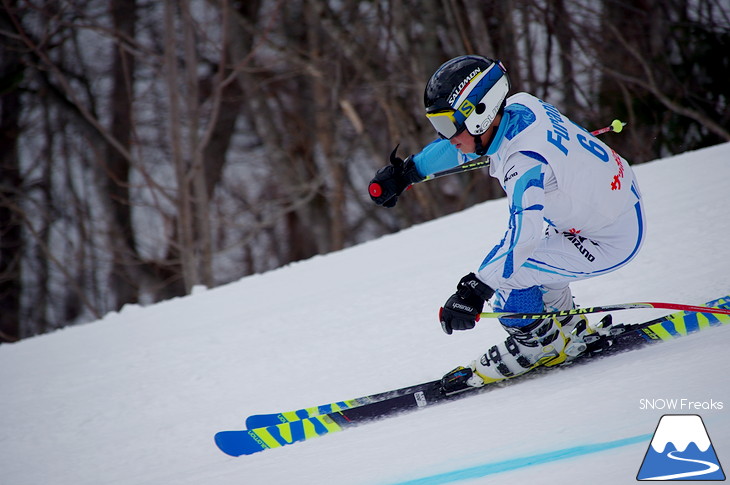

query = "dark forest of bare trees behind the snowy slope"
(0, 0), (730, 340)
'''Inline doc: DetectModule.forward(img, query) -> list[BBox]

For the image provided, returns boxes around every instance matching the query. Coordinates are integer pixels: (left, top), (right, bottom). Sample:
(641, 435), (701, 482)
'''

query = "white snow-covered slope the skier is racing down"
(0, 144), (730, 485)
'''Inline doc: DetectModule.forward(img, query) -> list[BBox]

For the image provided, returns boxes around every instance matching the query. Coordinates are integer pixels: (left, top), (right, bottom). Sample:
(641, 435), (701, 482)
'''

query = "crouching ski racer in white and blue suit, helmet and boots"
(369, 55), (645, 392)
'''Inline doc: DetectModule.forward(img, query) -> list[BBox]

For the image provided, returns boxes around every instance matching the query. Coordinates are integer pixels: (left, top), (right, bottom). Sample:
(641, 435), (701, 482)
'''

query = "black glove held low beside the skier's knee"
(439, 273), (494, 335)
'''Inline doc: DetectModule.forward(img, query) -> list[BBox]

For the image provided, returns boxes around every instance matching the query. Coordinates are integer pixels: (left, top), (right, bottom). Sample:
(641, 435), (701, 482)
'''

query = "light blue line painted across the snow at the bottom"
(386, 434), (652, 485)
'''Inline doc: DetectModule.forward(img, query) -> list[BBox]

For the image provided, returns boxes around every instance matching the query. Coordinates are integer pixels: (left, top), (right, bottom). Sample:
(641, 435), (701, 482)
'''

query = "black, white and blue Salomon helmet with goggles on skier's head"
(423, 56), (509, 139)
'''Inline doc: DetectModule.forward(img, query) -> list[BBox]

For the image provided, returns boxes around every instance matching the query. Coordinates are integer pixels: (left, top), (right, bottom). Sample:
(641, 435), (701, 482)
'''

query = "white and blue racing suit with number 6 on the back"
(414, 93), (645, 336)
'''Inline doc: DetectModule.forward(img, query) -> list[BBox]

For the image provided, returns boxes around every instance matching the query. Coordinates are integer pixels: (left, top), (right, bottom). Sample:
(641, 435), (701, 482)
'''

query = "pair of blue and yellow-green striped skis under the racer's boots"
(215, 296), (730, 456)
